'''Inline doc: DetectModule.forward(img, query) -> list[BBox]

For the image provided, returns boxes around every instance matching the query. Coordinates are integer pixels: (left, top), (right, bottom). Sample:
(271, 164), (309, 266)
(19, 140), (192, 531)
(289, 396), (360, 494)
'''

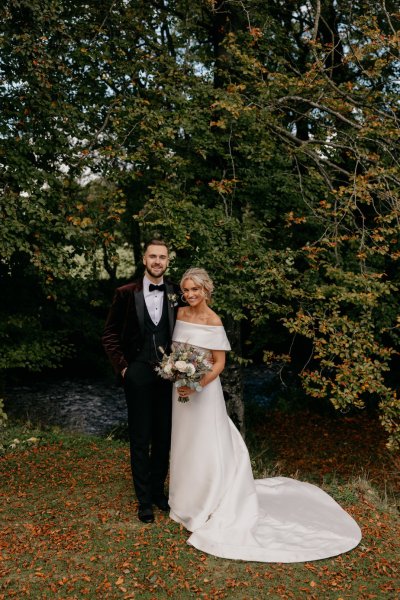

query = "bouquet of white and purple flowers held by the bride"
(156, 344), (212, 402)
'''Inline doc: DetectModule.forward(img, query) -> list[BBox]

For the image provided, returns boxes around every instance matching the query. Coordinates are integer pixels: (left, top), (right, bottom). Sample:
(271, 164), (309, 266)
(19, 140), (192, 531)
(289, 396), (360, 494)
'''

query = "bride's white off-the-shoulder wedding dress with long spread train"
(169, 321), (361, 563)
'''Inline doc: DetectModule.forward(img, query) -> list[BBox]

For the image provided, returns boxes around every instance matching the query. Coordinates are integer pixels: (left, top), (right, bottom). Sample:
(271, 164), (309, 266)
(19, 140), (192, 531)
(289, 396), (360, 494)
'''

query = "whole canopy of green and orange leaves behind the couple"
(0, 0), (400, 447)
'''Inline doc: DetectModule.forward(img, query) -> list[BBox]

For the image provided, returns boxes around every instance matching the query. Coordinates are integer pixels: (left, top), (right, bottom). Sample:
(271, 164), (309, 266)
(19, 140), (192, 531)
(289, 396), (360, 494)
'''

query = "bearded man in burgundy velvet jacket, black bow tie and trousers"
(102, 239), (180, 523)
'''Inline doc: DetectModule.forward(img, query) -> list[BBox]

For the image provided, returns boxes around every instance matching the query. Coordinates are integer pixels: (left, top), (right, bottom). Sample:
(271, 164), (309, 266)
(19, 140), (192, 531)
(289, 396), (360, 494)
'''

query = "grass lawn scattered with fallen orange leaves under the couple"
(0, 414), (400, 600)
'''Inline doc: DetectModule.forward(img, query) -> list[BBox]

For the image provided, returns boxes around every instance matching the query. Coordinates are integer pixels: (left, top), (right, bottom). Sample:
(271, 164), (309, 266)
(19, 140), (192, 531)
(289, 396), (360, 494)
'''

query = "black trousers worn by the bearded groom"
(124, 362), (172, 504)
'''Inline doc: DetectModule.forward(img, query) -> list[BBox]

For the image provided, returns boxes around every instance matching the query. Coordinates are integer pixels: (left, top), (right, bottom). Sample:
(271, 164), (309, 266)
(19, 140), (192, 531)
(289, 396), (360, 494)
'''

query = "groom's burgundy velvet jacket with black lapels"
(101, 279), (181, 376)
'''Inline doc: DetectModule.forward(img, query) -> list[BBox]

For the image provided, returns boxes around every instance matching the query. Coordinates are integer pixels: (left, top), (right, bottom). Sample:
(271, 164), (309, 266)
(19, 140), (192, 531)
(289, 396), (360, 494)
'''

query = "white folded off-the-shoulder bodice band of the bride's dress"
(172, 320), (231, 351)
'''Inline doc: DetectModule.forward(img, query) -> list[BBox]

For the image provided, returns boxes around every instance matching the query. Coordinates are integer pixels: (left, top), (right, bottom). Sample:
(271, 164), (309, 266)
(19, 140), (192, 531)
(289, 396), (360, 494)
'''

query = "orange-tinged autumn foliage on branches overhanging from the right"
(134, 3), (400, 448)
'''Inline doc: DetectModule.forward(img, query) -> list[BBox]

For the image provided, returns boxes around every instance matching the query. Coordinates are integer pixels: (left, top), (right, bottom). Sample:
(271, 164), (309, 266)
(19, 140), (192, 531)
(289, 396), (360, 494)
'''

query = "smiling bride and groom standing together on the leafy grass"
(103, 239), (361, 563)
